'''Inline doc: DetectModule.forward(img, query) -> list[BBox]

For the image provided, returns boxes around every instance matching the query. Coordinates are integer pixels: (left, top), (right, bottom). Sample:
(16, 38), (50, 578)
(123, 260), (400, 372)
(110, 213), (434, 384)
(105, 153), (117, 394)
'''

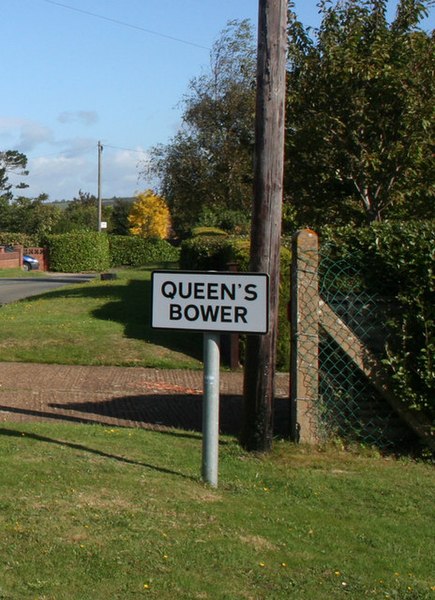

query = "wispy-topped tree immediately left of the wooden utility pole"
(143, 21), (256, 237)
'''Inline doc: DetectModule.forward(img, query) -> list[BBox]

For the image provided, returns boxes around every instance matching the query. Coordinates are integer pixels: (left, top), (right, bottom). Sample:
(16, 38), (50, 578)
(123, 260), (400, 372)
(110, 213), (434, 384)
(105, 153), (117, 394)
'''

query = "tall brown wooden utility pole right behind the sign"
(241, 0), (287, 452)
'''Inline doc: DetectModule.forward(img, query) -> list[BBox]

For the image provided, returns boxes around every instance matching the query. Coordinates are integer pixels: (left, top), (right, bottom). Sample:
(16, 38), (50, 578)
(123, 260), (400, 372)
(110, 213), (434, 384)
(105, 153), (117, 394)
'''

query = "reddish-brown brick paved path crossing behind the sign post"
(0, 363), (289, 435)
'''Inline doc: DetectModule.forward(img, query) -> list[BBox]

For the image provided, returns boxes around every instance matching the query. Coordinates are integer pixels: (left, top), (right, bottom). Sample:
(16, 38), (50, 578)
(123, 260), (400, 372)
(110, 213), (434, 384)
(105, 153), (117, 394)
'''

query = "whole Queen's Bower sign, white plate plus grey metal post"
(151, 271), (269, 487)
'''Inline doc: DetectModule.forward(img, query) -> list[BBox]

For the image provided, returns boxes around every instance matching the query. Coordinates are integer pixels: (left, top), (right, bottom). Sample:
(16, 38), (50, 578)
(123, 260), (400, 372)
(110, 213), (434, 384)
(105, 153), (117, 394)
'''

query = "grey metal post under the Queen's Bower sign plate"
(202, 331), (220, 487)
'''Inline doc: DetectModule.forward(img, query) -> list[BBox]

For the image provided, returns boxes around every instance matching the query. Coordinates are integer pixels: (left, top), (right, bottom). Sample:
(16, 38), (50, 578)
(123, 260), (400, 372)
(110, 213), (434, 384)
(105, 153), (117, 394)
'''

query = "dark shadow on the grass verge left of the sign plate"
(22, 279), (202, 361)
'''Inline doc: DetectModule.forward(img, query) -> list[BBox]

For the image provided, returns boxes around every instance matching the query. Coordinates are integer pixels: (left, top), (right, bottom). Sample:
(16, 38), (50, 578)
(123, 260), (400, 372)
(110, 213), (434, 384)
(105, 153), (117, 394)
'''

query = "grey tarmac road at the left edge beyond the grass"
(0, 274), (95, 305)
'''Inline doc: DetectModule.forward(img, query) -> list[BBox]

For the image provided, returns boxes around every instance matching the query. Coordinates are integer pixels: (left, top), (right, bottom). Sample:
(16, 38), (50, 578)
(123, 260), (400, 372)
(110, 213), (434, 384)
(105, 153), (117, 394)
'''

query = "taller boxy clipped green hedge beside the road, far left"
(47, 231), (110, 273)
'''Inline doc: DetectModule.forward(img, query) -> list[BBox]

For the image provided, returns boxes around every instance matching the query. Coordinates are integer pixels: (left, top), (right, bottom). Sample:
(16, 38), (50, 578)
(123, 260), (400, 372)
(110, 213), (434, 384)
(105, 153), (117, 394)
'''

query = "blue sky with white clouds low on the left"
(0, 0), (433, 200)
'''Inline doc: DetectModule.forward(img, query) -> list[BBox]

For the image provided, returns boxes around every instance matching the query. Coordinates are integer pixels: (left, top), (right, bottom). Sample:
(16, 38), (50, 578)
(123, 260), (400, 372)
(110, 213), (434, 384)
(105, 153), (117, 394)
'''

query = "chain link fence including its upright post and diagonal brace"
(291, 230), (415, 449)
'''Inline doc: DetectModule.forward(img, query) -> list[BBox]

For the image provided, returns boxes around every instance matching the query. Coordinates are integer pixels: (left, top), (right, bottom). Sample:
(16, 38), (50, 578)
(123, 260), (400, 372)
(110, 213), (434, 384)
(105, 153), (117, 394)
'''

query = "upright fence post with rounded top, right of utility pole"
(290, 229), (319, 444)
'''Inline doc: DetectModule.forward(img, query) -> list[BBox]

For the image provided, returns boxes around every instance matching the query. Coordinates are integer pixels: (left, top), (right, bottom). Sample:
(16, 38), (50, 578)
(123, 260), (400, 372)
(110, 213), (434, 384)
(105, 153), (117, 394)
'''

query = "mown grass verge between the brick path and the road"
(0, 269), (202, 368)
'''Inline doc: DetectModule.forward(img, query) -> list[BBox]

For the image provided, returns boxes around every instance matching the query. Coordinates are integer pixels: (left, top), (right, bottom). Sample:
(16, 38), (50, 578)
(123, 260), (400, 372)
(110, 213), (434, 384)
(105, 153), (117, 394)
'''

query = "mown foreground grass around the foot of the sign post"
(0, 423), (435, 600)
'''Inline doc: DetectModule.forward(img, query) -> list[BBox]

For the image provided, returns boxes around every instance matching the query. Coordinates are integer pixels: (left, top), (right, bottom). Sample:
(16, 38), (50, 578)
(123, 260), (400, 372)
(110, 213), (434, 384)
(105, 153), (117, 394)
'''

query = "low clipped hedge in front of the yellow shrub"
(109, 235), (180, 267)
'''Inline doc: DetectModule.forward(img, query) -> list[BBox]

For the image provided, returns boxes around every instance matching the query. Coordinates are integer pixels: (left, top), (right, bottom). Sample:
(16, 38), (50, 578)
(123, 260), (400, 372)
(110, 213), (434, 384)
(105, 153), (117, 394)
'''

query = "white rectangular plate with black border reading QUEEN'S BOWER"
(152, 271), (269, 333)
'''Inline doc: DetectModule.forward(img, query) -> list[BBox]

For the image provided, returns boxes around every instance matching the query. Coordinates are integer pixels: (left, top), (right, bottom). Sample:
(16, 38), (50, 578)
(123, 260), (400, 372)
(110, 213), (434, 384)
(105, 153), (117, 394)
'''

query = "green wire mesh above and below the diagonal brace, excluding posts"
(318, 248), (409, 448)
